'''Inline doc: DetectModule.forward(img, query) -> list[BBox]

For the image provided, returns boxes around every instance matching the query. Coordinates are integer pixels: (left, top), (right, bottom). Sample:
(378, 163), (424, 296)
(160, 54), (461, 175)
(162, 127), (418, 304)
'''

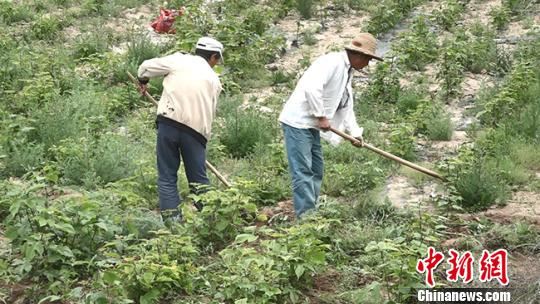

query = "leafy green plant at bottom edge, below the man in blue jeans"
(216, 222), (329, 303)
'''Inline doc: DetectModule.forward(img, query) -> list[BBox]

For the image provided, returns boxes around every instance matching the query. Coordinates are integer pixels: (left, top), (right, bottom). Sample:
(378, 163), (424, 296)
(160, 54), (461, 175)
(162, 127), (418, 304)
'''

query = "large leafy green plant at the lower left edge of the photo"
(2, 180), (120, 290)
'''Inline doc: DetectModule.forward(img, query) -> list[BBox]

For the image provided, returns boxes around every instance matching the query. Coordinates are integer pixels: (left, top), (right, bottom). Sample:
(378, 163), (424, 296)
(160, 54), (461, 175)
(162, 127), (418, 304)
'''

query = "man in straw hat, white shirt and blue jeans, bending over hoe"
(279, 33), (382, 217)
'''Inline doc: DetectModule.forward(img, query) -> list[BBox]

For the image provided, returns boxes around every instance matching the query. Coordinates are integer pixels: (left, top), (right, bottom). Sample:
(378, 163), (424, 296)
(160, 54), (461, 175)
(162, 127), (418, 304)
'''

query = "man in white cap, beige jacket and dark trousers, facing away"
(138, 37), (223, 221)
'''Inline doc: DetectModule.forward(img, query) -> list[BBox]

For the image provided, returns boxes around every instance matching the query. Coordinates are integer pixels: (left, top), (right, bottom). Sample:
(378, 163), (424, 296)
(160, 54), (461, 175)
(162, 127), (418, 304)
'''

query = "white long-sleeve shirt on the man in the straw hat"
(279, 51), (363, 144)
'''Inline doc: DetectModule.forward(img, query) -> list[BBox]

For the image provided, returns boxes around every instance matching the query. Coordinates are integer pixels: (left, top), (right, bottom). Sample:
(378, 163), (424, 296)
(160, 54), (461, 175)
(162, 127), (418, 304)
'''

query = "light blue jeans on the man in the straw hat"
(282, 124), (323, 217)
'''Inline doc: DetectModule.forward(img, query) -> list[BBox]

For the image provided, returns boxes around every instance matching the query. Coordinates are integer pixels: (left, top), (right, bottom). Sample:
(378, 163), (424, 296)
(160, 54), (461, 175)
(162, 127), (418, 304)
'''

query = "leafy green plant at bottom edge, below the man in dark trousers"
(101, 230), (200, 304)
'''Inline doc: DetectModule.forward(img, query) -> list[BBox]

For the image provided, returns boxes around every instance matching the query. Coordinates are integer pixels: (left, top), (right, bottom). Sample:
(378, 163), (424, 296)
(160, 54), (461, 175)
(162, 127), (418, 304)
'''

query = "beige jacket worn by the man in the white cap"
(138, 53), (222, 139)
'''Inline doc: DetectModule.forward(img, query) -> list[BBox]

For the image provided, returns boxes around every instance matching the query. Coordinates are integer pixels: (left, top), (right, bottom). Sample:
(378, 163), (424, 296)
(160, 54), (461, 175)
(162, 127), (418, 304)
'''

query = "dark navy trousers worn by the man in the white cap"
(156, 122), (210, 211)
